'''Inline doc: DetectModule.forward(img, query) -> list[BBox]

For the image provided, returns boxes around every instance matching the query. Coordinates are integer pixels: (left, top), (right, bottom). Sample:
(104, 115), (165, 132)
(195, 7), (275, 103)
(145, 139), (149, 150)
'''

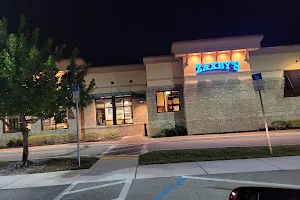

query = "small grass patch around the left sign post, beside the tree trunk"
(27, 157), (99, 174)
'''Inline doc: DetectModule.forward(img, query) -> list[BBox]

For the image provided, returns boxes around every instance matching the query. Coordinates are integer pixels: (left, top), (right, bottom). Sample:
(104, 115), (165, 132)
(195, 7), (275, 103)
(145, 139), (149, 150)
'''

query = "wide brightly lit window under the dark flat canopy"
(96, 96), (133, 125)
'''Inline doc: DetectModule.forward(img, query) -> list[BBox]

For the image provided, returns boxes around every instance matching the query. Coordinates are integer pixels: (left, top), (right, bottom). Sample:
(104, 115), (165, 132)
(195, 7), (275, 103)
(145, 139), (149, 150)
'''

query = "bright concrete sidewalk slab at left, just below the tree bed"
(2, 170), (86, 189)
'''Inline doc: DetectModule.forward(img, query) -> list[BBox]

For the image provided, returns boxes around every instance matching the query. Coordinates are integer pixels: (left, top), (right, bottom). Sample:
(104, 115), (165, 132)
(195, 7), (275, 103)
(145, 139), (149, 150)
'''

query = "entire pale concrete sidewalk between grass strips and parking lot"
(0, 156), (300, 189)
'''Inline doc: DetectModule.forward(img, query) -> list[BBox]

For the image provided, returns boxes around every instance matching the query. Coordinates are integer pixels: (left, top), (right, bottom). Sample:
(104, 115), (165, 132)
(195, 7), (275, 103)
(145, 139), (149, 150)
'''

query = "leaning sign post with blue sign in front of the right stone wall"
(252, 73), (273, 155)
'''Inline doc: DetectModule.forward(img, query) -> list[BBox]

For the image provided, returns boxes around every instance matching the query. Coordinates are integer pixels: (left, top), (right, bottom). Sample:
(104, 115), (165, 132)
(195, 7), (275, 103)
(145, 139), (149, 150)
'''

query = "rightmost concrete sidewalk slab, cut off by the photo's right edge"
(259, 156), (300, 170)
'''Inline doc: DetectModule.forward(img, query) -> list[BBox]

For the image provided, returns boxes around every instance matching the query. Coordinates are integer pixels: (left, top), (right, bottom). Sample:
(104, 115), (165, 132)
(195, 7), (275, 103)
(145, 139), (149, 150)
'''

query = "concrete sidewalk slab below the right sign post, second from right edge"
(198, 159), (280, 174)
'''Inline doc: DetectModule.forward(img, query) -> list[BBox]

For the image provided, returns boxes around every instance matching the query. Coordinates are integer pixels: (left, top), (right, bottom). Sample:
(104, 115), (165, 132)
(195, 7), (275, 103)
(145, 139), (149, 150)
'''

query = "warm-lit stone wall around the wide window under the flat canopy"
(81, 99), (148, 137)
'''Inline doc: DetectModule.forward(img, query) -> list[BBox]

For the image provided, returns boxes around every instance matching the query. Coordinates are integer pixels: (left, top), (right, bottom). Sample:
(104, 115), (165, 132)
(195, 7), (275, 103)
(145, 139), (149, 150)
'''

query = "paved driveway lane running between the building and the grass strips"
(0, 130), (300, 161)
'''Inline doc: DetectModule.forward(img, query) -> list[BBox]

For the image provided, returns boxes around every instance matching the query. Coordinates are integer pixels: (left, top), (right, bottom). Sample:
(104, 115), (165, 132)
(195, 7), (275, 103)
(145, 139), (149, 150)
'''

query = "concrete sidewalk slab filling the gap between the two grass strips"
(77, 158), (138, 183)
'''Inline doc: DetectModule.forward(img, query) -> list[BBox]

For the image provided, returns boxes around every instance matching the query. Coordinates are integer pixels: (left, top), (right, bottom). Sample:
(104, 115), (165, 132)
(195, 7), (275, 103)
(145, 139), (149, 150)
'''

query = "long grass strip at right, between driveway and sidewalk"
(139, 145), (300, 165)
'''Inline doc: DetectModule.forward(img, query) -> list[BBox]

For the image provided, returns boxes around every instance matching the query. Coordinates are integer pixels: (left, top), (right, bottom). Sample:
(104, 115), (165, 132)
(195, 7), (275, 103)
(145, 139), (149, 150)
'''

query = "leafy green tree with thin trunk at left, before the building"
(0, 16), (94, 166)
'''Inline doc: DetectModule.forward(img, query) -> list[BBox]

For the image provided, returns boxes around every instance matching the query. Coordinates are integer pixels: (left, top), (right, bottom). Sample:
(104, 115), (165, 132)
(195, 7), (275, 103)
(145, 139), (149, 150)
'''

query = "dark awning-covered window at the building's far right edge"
(284, 70), (300, 97)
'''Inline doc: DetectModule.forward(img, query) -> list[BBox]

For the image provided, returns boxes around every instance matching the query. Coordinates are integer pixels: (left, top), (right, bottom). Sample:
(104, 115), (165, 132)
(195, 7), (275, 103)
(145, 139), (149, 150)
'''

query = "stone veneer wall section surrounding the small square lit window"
(147, 86), (186, 136)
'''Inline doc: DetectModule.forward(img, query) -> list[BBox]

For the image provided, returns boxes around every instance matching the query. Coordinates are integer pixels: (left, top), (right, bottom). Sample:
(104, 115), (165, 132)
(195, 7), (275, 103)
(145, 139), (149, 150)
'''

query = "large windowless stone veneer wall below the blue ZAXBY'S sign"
(184, 78), (300, 134)
